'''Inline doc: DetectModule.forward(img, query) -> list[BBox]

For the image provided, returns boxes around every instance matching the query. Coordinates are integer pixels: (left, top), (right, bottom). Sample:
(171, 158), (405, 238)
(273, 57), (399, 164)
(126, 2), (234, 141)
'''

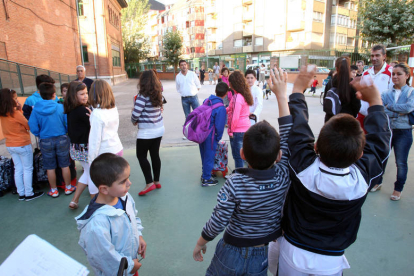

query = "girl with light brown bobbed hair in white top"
(88, 80), (123, 165)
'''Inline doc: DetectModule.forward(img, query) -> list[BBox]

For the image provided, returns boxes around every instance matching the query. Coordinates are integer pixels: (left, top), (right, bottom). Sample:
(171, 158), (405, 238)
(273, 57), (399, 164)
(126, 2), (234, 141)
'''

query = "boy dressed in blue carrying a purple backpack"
(199, 82), (229, 187)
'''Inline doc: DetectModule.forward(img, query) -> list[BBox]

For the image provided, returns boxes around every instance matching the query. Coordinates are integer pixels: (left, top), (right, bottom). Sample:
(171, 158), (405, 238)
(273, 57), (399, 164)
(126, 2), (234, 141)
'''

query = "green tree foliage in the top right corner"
(358, 0), (414, 46)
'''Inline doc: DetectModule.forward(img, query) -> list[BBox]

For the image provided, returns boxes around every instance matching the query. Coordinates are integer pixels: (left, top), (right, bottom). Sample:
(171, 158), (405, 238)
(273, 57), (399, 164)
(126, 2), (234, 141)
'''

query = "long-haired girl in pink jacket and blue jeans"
(227, 71), (253, 168)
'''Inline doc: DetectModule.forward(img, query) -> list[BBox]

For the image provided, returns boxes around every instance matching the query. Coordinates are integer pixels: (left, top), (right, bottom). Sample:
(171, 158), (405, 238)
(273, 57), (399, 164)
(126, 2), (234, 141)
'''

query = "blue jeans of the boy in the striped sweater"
(206, 239), (268, 276)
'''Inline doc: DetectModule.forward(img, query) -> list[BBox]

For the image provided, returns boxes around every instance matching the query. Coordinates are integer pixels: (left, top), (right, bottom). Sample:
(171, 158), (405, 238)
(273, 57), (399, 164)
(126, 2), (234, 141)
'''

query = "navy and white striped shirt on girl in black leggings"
(131, 95), (164, 128)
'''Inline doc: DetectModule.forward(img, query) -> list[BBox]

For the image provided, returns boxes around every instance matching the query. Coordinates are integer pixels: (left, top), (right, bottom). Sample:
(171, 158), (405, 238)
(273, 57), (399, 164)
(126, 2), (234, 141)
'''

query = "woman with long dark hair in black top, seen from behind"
(324, 56), (361, 123)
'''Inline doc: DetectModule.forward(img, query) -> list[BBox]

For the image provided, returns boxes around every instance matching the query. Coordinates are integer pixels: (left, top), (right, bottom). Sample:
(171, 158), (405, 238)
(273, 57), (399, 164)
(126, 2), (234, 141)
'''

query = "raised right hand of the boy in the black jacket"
(351, 76), (382, 106)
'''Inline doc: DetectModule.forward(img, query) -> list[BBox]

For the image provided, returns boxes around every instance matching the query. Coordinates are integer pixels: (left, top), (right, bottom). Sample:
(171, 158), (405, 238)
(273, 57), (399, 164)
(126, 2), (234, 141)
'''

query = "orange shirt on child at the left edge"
(0, 110), (32, 147)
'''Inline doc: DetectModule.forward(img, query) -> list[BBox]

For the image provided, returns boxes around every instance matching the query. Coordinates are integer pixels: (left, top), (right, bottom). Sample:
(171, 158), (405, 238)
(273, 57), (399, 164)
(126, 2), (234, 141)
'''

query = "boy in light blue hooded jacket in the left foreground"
(75, 153), (147, 276)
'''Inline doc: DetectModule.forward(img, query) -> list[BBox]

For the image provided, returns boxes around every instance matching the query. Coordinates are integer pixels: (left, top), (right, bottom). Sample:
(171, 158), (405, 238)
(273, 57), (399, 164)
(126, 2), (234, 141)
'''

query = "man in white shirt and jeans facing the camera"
(175, 60), (201, 118)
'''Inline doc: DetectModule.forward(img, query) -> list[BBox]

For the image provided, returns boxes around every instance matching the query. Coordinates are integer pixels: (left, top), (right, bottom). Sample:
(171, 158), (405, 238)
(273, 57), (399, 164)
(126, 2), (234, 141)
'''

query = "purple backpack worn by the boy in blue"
(183, 100), (224, 144)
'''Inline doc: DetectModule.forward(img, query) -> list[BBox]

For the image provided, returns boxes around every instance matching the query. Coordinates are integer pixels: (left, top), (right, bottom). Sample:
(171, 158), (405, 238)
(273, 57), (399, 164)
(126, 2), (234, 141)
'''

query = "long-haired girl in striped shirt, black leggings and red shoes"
(131, 70), (165, 196)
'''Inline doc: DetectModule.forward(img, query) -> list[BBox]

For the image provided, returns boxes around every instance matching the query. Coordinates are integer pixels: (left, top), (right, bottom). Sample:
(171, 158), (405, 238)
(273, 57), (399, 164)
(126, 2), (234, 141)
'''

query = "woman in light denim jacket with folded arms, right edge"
(371, 63), (414, 200)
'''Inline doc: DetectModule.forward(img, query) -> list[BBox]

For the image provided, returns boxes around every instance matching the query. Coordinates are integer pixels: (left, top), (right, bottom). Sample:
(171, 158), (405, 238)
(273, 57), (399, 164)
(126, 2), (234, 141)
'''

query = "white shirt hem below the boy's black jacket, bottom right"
(277, 237), (350, 275)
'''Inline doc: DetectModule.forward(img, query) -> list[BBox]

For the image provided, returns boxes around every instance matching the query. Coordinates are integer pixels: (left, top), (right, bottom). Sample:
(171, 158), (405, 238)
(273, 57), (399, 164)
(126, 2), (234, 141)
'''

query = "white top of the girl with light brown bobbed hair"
(88, 107), (123, 164)
